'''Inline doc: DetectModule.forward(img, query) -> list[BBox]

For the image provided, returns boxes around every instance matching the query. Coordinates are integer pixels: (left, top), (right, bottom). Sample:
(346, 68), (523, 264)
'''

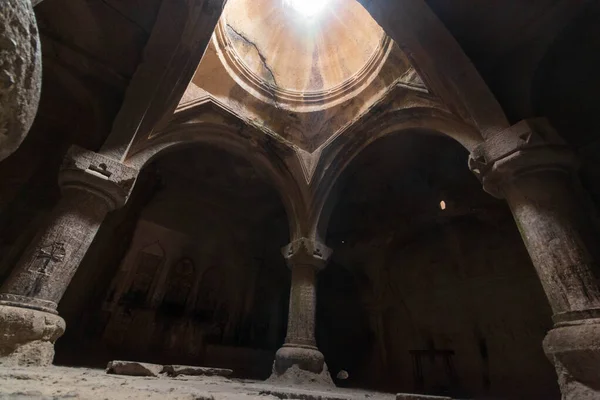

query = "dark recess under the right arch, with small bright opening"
(316, 128), (558, 398)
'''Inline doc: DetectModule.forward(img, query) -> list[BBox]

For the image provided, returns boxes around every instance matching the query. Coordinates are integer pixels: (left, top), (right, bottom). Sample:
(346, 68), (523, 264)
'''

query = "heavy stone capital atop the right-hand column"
(469, 118), (578, 198)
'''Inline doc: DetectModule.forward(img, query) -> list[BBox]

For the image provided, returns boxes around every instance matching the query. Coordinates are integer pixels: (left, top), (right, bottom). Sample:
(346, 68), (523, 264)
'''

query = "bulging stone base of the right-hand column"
(544, 319), (600, 400)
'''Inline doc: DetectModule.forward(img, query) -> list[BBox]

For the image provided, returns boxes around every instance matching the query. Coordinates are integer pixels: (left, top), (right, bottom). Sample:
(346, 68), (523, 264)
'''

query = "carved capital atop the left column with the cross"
(58, 146), (139, 210)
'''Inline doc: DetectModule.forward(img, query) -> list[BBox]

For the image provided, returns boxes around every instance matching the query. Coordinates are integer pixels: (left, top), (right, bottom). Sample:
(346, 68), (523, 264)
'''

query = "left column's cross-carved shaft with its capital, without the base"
(0, 148), (136, 313)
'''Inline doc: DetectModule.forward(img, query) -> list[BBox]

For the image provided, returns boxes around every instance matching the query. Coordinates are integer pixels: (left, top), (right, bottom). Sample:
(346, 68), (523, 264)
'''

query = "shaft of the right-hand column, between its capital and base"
(504, 168), (600, 322)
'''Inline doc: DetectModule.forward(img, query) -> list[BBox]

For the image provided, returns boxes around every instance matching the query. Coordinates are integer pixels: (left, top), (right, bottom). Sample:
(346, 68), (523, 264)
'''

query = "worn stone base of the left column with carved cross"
(0, 305), (65, 366)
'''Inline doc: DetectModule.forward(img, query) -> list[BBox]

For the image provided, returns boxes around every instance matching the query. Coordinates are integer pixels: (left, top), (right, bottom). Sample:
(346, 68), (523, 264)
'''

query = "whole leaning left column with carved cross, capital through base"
(0, 147), (137, 365)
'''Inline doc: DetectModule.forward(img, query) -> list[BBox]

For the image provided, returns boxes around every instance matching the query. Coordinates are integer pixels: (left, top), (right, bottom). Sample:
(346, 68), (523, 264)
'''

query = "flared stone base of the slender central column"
(268, 344), (335, 386)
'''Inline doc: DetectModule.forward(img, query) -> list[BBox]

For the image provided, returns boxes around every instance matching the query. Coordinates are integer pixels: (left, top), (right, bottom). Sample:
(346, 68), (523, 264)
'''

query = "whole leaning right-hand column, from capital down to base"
(470, 119), (600, 400)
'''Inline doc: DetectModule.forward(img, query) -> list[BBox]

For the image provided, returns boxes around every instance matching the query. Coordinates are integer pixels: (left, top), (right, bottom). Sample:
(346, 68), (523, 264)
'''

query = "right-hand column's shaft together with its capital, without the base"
(470, 120), (600, 322)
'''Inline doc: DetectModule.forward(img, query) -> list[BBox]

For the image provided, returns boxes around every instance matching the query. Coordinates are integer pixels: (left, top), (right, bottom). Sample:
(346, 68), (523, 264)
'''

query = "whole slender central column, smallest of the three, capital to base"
(271, 238), (333, 385)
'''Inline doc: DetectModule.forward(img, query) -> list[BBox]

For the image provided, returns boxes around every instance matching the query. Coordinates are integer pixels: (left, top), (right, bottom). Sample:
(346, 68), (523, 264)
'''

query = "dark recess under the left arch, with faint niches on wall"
(57, 143), (290, 378)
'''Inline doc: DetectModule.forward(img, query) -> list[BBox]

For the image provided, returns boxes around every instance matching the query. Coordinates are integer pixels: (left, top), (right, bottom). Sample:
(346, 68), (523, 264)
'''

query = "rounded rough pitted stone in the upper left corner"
(0, 0), (42, 160)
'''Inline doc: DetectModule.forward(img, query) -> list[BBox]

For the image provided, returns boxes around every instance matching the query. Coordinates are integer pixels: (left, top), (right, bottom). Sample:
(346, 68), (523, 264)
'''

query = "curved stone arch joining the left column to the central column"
(125, 122), (307, 238)
